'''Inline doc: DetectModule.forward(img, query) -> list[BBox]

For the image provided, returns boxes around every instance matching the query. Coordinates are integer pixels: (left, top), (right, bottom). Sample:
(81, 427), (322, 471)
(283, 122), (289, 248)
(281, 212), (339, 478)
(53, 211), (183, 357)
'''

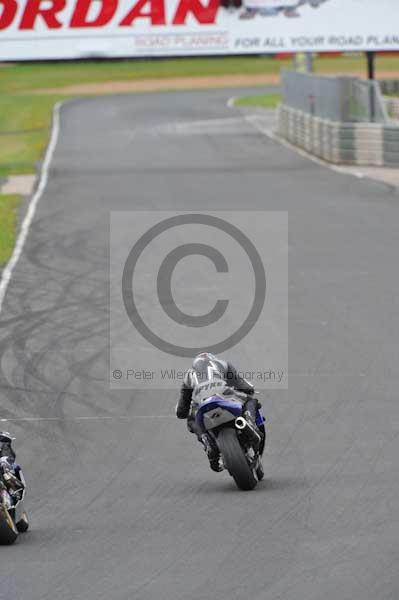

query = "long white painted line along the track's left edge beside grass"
(0, 102), (63, 312)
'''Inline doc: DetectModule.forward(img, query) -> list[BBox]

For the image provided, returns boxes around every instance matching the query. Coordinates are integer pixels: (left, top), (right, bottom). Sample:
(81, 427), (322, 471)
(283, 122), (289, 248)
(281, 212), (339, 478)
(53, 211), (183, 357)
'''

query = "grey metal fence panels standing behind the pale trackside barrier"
(281, 70), (389, 123)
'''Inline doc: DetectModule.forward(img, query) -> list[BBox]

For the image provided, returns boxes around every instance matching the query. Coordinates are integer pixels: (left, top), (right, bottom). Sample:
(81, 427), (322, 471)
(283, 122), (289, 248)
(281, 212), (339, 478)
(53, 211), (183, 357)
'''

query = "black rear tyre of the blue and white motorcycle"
(217, 429), (258, 490)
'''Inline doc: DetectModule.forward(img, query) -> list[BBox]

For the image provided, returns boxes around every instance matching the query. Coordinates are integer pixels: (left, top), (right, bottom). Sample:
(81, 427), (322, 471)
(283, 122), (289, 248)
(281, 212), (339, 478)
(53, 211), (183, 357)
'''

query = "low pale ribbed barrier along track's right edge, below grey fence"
(277, 104), (399, 167)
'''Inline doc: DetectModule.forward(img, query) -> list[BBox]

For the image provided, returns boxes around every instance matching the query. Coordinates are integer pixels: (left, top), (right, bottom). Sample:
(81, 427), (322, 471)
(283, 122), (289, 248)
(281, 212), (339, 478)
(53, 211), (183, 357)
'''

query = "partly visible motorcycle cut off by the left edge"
(0, 459), (29, 545)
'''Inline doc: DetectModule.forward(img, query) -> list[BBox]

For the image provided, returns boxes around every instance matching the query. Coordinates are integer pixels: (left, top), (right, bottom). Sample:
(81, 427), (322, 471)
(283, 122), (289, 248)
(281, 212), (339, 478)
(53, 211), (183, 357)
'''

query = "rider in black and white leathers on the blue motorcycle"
(176, 352), (264, 471)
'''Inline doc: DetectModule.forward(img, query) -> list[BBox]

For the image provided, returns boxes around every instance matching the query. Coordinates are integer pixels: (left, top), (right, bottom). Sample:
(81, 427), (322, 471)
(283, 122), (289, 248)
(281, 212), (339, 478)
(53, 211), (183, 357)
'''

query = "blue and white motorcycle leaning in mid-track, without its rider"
(193, 380), (266, 490)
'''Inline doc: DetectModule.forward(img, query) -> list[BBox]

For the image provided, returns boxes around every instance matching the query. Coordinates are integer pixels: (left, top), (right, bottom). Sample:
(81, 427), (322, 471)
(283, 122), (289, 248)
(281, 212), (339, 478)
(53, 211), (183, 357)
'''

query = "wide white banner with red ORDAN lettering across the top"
(0, 0), (399, 60)
